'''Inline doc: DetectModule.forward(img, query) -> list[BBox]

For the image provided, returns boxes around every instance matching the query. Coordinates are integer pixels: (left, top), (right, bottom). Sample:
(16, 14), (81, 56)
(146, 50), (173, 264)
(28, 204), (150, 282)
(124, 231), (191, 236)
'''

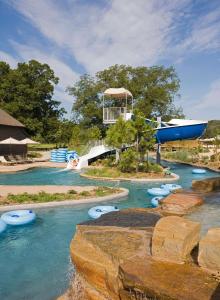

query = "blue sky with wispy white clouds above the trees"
(0, 0), (220, 120)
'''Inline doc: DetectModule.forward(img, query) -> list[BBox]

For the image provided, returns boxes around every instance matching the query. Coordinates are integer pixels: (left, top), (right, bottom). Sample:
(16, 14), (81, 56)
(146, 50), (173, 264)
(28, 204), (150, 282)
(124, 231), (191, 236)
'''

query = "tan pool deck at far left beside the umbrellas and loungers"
(0, 161), (66, 173)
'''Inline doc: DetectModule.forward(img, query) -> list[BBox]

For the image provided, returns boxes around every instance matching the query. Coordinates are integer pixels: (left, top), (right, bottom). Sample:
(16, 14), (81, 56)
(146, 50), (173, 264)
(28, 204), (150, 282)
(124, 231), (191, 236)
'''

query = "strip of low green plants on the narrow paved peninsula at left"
(0, 186), (121, 205)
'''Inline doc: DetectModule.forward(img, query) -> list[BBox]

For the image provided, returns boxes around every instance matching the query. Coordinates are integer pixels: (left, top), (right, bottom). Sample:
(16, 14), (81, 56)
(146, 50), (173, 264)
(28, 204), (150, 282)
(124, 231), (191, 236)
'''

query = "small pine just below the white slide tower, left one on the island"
(105, 118), (135, 163)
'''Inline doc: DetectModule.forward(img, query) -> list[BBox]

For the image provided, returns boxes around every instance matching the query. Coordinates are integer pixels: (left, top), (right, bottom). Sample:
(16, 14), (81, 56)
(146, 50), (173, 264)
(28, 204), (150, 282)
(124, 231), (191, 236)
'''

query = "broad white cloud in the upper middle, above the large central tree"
(9, 0), (189, 73)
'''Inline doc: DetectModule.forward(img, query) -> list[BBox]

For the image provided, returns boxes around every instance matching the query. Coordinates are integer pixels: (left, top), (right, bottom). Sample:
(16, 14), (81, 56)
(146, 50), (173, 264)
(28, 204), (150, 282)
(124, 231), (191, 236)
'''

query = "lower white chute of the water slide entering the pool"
(75, 145), (114, 170)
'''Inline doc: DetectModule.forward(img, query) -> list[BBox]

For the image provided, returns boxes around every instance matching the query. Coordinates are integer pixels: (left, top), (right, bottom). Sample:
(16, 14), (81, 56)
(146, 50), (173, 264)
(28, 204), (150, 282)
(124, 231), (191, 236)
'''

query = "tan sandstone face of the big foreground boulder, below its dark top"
(70, 219), (155, 300)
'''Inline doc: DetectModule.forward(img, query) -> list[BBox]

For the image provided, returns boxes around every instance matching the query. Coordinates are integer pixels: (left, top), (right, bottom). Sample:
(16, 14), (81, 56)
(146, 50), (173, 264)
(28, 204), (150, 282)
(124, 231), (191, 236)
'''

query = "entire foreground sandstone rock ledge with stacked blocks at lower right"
(60, 209), (220, 300)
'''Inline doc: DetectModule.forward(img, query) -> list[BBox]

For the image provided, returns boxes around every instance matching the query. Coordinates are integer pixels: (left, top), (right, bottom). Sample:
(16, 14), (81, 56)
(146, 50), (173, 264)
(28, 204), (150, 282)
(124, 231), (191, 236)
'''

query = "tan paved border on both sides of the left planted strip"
(0, 185), (129, 211)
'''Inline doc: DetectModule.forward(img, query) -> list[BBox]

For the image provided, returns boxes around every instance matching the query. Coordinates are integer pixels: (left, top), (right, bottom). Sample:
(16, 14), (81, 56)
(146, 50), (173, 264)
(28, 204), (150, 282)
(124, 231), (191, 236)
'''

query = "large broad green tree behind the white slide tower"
(67, 65), (182, 128)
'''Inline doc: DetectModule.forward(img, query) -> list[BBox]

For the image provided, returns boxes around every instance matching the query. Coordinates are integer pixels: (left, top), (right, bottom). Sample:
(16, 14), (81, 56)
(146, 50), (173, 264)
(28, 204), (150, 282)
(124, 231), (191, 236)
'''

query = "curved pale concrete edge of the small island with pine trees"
(80, 173), (180, 183)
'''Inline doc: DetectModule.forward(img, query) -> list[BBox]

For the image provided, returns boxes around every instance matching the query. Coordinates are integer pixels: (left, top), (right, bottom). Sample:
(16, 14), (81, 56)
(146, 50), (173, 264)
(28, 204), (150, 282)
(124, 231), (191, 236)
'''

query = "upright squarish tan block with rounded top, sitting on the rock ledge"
(152, 216), (201, 264)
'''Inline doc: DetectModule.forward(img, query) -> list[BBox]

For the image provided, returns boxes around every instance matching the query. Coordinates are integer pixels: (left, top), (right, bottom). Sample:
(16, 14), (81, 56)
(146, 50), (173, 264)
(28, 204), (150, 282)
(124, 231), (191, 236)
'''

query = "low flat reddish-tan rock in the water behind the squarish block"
(160, 192), (203, 215)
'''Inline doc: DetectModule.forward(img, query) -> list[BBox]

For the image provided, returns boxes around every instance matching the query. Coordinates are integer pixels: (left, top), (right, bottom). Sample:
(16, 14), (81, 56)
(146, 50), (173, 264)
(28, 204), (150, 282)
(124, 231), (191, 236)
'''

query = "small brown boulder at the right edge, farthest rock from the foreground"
(192, 177), (220, 193)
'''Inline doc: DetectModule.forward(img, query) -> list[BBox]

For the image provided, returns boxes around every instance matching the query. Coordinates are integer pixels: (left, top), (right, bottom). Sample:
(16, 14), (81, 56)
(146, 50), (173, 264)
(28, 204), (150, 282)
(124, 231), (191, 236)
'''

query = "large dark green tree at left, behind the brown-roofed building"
(0, 60), (65, 142)
